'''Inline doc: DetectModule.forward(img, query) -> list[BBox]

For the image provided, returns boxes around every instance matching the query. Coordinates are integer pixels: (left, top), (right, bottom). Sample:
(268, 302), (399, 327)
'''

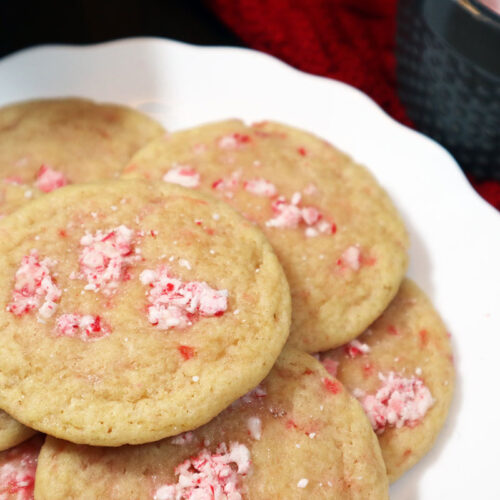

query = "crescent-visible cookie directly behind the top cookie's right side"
(124, 120), (408, 352)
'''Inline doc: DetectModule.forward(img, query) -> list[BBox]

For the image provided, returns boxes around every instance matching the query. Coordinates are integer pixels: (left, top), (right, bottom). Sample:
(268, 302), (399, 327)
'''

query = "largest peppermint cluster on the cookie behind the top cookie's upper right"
(266, 193), (337, 238)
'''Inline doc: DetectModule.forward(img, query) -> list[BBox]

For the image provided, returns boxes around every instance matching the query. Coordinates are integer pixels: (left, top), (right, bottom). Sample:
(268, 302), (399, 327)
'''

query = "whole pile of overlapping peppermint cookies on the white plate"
(0, 99), (453, 500)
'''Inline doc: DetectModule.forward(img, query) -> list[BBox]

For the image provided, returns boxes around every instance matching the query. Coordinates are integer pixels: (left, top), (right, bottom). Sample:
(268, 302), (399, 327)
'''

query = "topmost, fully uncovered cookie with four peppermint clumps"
(0, 181), (290, 446)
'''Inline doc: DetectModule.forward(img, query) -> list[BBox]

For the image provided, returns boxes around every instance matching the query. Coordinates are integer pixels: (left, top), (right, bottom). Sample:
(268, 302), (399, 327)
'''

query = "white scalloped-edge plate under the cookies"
(0, 39), (500, 500)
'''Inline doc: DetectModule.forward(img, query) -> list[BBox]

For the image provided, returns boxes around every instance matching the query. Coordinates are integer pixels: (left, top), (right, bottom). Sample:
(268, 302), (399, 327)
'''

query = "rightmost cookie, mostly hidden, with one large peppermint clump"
(321, 279), (454, 482)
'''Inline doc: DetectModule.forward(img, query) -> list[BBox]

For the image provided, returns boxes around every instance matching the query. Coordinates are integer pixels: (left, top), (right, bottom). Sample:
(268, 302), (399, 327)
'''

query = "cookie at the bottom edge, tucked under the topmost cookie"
(36, 348), (388, 500)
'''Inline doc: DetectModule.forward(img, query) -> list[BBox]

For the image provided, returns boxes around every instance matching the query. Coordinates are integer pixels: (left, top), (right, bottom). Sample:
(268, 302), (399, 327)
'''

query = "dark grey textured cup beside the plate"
(396, 0), (500, 180)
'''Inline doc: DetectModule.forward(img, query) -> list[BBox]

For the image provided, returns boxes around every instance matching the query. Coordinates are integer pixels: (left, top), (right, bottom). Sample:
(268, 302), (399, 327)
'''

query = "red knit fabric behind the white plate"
(208, 0), (500, 209)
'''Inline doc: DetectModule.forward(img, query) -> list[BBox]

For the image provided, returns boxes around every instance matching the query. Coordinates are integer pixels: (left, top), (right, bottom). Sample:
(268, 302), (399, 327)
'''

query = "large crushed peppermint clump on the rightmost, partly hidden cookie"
(357, 372), (434, 434)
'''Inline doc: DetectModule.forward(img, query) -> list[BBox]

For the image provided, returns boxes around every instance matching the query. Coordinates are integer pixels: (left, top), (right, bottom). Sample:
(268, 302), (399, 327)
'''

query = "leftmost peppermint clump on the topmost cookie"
(7, 250), (62, 319)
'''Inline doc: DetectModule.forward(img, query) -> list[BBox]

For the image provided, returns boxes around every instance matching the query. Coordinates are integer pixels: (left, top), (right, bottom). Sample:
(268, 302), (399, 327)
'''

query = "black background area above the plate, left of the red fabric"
(0, 0), (242, 57)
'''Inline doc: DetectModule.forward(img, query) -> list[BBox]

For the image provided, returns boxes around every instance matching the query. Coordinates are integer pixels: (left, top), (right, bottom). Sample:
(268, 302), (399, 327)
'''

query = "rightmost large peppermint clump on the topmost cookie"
(140, 266), (228, 330)
